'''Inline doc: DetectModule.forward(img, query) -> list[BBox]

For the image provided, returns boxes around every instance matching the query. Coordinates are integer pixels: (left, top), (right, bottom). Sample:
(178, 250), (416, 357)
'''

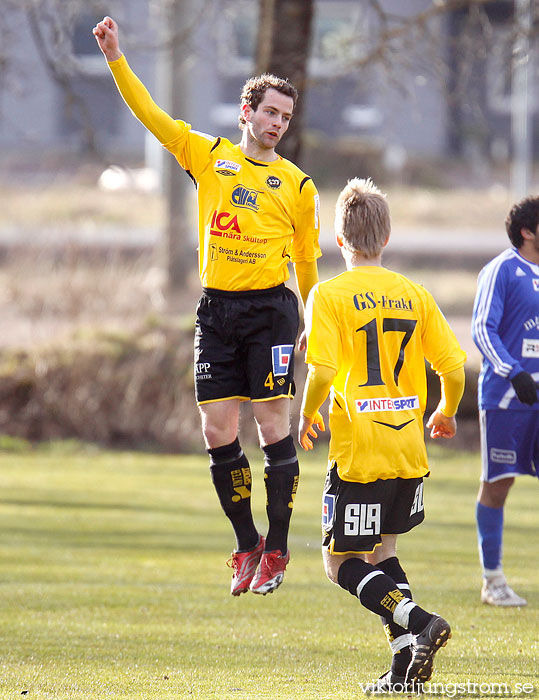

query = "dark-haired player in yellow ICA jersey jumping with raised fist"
(93, 17), (321, 596)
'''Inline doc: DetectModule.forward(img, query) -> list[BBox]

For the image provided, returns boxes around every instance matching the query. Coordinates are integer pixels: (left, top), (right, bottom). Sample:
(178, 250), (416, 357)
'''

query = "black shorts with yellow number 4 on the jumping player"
(195, 284), (299, 404)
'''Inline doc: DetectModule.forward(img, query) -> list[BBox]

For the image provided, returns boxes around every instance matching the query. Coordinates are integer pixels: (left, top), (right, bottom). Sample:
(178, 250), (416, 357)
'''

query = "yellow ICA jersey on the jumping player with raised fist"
(109, 56), (322, 292)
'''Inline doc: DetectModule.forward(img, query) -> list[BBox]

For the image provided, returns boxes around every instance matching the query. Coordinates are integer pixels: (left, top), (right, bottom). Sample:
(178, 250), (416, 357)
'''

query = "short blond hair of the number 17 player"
(335, 177), (391, 259)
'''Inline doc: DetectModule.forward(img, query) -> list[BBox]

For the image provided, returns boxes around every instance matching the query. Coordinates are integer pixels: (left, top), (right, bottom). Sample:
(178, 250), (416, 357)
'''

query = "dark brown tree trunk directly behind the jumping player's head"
(256, 0), (313, 163)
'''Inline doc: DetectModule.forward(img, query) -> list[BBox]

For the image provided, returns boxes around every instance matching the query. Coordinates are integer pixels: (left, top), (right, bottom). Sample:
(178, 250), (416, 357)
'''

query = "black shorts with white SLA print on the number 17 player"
(322, 466), (425, 554)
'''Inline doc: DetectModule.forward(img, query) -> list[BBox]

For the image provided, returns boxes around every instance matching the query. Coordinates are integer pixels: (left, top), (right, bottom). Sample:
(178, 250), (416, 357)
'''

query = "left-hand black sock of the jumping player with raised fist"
(208, 438), (259, 551)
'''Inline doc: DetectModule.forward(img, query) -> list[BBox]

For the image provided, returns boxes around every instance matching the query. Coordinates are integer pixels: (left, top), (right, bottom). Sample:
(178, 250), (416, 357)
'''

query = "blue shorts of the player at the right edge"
(479, 408), (539, 481)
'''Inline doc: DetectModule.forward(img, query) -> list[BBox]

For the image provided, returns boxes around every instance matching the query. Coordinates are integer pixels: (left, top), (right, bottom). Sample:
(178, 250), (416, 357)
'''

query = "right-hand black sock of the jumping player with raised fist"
(262, 435), (299, 555)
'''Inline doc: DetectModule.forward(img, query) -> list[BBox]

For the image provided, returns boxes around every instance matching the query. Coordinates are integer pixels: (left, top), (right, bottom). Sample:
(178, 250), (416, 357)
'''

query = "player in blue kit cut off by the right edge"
(472, 197), (539, 607)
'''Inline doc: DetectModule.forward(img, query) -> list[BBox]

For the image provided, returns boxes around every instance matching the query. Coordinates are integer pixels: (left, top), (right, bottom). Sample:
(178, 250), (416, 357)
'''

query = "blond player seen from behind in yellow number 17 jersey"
(299, 179), (466, 692)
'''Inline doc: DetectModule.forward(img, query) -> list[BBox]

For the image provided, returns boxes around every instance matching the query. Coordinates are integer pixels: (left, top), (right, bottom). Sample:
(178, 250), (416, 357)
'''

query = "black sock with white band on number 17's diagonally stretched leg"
(338, 558), (432, 634)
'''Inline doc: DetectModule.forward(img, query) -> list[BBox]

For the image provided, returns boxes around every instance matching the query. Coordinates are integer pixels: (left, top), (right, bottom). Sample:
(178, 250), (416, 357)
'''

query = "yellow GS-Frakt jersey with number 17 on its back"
(305, 266), (466, 483)
